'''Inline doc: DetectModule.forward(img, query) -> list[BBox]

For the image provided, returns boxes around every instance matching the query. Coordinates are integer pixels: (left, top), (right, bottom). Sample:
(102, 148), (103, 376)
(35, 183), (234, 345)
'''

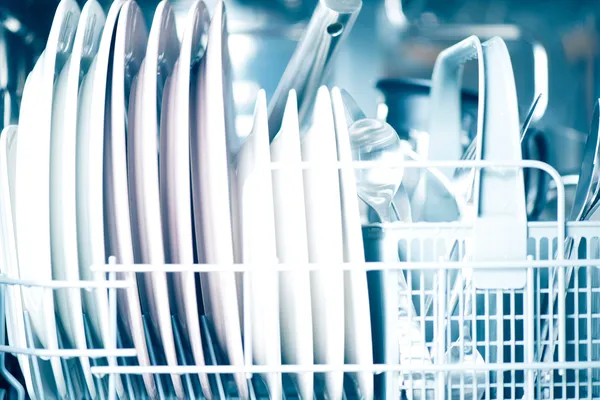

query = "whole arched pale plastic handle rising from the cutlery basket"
(427, 36), (527, 290)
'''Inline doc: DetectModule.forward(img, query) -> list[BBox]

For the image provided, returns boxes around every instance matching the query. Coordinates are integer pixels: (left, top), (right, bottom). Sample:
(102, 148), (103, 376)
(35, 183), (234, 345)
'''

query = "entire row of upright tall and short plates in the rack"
(0, 0), (373, 399)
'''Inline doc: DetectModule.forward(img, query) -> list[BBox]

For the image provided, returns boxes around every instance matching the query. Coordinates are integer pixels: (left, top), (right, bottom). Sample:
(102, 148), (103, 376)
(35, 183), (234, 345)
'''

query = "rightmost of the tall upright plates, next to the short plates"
(191, 2), (248, 399)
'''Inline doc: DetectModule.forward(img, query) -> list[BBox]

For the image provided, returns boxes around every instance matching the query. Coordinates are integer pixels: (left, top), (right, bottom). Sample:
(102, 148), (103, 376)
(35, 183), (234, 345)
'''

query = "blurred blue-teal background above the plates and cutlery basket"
(0, 0), (600, 175)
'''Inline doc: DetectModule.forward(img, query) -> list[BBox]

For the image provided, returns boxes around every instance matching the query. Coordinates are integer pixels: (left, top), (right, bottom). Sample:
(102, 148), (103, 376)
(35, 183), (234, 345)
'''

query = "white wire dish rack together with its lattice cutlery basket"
(0, 157), (600, 399)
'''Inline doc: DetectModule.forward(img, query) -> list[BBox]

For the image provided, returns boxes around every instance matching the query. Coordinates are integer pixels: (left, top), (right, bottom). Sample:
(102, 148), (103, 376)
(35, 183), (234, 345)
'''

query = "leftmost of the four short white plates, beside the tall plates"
(237, 90), (282, 399)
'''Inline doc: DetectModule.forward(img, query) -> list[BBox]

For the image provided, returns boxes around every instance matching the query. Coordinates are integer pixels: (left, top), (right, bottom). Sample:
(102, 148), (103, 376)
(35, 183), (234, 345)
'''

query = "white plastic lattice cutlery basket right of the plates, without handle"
(363, 222), (600, 399)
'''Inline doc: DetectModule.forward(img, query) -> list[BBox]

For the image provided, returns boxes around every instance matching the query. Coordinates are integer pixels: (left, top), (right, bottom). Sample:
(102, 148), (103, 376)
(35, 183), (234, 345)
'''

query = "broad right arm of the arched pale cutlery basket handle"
(472, 37), (527, 289)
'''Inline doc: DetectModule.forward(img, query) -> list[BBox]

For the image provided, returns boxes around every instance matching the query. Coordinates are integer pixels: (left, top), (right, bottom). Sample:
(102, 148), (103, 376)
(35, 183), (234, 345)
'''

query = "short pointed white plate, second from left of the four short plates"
(271, 90), (314, 399)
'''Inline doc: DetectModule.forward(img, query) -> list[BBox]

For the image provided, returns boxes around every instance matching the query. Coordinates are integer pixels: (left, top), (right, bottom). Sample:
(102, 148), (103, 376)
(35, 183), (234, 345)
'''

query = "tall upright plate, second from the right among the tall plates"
(160, 1), (211, 397)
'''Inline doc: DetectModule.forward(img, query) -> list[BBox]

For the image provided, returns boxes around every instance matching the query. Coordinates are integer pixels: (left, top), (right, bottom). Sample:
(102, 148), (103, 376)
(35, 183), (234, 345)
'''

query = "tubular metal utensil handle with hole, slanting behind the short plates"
(269, 0), (362, 140)
